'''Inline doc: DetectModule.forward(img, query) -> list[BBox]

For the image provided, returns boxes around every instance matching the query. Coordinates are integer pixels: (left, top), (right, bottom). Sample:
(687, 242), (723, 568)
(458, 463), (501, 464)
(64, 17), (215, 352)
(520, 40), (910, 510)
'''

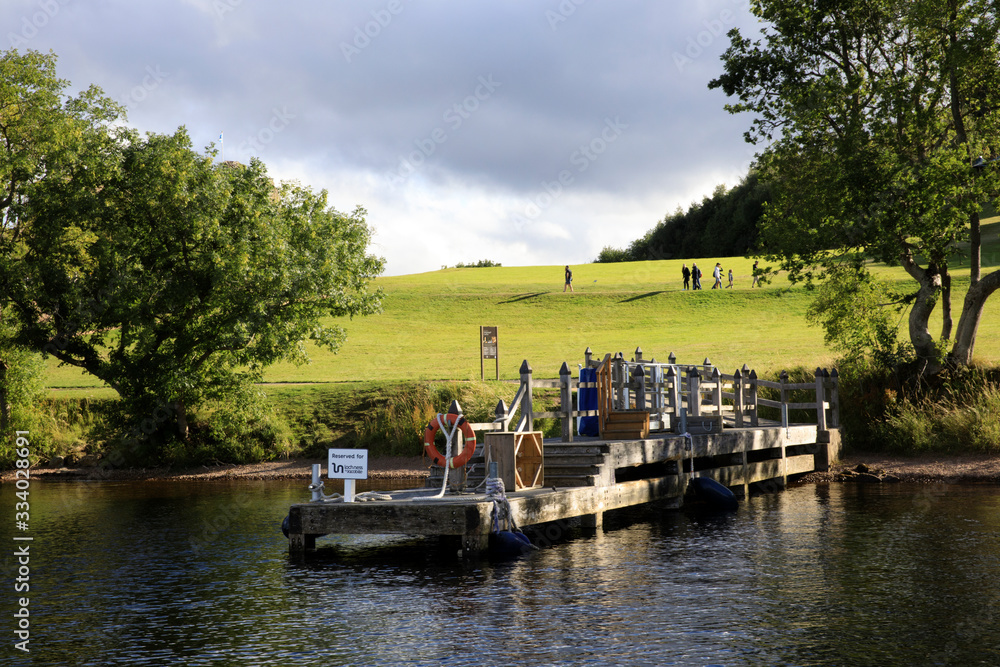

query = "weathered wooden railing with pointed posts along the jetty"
(472, 348), (840, 442)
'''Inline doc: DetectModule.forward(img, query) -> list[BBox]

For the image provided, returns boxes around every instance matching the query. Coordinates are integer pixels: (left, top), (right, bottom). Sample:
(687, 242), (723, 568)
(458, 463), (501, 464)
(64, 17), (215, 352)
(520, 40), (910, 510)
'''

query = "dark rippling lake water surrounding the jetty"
(0, 481), (1000, 666)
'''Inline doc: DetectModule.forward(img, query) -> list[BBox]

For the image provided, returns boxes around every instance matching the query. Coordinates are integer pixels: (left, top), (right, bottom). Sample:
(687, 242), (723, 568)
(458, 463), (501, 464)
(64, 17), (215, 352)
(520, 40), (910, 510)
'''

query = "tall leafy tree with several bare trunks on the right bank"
(709, 0), (1000, 373)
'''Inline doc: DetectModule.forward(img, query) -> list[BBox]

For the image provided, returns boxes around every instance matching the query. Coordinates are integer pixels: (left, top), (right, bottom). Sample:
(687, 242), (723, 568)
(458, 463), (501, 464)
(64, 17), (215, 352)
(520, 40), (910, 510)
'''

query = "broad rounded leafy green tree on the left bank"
(0, 49), (383, 448)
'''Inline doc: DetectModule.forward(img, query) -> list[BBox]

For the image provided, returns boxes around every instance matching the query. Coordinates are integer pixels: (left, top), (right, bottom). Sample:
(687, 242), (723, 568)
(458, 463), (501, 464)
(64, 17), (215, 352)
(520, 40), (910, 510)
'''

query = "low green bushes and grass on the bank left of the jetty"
(0, 382), (559, 469)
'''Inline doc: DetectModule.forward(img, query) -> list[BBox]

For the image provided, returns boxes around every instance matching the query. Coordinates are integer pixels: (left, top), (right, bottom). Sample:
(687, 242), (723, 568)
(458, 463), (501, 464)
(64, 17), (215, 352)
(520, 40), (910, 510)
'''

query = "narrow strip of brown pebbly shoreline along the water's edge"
(0, 452), (1000, 484)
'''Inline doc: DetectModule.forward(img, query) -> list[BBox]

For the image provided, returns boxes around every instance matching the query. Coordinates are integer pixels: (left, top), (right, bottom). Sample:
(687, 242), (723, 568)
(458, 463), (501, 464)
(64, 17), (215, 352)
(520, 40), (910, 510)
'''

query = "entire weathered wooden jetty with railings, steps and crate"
(288, 348), (840, 556)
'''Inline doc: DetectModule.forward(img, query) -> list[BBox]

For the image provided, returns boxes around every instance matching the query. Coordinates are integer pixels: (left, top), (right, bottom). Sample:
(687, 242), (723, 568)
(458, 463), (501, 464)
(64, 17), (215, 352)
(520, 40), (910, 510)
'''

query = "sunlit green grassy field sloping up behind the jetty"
(48, 218), (1000, 388)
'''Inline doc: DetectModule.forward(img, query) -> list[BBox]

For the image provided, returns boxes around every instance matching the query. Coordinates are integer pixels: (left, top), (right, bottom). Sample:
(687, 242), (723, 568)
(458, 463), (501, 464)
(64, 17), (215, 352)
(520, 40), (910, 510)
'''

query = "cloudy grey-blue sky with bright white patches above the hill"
(0, 0), (757, 275)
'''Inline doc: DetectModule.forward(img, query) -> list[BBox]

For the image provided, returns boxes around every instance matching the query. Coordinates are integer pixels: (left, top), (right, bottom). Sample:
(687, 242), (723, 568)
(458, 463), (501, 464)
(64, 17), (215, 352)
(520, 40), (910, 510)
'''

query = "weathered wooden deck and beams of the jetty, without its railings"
(288, 424), (840, 556)
